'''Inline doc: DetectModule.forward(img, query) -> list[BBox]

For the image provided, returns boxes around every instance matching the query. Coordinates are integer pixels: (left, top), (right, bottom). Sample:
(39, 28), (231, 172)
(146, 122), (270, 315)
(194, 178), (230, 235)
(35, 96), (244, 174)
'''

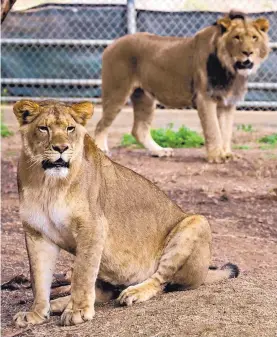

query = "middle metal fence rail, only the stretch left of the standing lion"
(0, 78), (102, 86)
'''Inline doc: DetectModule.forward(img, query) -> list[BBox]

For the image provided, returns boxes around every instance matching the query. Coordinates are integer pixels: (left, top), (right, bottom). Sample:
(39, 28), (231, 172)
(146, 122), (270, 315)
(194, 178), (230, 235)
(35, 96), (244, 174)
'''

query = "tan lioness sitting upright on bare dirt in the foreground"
(14, 101), (238, 327)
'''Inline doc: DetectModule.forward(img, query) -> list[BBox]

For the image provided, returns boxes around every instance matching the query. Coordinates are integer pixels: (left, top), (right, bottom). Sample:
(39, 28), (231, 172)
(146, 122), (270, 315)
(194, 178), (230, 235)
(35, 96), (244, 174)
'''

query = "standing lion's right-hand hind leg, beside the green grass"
(131, 88), (173, 157)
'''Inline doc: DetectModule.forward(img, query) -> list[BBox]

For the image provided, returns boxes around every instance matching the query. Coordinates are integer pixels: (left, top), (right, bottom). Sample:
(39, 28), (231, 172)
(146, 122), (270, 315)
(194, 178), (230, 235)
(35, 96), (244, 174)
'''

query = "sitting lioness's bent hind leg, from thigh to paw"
(118, 215), (211, 305)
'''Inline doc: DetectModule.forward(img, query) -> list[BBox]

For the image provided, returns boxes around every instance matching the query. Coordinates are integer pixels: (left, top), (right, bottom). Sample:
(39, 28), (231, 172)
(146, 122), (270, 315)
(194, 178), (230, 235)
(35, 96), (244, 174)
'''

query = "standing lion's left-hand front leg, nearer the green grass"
(197, 95), (225, 163)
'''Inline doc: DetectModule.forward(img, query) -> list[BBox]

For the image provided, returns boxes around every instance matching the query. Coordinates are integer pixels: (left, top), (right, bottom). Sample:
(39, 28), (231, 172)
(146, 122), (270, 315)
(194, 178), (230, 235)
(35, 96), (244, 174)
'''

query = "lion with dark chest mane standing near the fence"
(95, 12), (269, 163)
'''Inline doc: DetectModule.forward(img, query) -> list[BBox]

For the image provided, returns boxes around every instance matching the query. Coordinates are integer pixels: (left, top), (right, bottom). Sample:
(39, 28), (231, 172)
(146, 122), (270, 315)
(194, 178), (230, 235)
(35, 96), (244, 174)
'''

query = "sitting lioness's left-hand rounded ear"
(13, 100), (39, 126)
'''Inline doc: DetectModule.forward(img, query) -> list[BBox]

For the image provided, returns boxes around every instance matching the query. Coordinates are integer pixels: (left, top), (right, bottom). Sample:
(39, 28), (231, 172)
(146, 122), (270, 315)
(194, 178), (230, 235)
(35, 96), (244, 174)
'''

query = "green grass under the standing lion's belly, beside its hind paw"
(121, 123), (204, 148)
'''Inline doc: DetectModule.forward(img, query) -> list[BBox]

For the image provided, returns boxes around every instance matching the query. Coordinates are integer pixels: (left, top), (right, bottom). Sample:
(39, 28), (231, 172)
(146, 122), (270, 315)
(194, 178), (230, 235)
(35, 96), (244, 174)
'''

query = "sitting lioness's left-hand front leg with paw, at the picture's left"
(13, 230), (59, 327)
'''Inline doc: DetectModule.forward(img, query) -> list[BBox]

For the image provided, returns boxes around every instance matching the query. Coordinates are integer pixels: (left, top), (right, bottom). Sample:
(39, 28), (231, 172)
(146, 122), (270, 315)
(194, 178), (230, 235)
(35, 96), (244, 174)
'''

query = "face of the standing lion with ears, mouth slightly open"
(217, 17), (269, 76)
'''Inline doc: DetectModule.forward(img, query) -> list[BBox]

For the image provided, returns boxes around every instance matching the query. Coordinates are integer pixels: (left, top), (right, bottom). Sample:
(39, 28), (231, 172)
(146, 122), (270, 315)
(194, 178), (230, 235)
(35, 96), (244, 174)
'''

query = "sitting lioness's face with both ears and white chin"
(14, 101), (93, 178)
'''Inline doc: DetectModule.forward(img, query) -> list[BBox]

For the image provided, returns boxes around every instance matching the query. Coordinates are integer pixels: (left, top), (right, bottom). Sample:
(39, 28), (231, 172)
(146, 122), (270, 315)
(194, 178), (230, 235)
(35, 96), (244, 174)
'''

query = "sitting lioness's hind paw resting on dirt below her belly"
(117, 284), (161, 306)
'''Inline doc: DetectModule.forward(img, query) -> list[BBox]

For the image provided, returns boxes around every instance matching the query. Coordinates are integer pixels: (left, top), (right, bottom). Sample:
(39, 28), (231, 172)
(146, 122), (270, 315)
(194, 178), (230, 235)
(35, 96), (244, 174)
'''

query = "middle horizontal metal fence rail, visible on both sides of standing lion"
(0, 78), (277, 90)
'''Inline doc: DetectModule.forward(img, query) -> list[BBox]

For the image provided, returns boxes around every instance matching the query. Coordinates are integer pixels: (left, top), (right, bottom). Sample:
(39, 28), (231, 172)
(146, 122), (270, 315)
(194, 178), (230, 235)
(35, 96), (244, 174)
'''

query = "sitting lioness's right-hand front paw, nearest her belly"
(61, 307), (95, 325)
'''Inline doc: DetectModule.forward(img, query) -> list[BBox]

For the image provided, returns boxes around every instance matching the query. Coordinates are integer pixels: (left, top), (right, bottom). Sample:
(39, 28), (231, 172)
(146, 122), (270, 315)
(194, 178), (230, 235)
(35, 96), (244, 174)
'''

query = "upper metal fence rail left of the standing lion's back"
(1, 39), (113, 47)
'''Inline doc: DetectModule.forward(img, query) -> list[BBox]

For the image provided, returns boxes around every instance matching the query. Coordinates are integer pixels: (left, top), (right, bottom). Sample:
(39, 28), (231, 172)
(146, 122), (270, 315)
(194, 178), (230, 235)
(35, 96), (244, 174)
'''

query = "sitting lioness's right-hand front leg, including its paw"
(61, 221), (104, 325)
